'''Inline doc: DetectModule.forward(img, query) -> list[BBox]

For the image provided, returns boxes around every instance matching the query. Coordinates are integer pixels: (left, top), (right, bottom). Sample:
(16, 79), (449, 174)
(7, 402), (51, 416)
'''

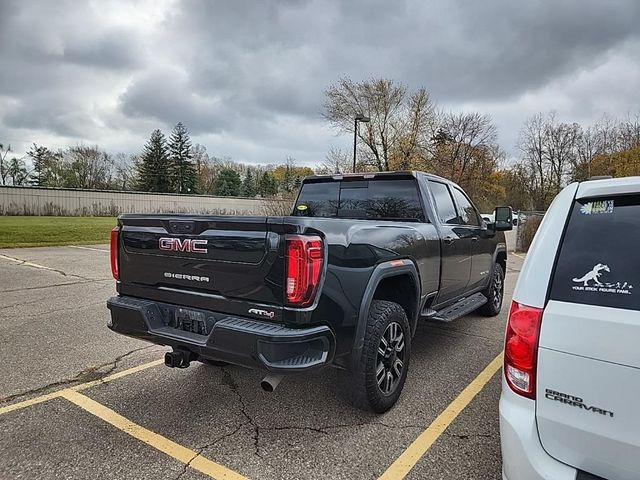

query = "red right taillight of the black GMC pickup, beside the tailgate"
(285, 235), (324, 307)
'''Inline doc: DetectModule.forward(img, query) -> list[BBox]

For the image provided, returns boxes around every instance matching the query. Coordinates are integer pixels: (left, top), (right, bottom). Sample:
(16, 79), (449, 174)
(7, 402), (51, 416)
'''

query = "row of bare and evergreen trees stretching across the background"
(0, 78), (640, 211)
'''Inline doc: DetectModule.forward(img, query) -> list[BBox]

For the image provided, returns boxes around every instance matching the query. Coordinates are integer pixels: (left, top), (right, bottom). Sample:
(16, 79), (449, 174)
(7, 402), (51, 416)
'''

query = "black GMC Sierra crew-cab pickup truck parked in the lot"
(108, 172), (511, 412)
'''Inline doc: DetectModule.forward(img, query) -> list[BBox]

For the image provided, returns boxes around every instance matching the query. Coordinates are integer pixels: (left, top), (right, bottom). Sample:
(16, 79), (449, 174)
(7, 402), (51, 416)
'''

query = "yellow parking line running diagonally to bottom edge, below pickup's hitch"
(60, 389), (245, 480)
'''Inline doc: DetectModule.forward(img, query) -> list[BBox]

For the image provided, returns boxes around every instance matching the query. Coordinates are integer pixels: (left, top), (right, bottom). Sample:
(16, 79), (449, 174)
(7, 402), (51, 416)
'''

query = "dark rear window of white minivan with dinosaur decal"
(550, 195), (640, 310)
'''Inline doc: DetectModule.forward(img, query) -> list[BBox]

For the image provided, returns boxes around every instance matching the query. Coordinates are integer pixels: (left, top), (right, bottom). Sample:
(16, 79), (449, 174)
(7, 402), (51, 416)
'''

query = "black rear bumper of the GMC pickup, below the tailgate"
(107, 296), (335, 373)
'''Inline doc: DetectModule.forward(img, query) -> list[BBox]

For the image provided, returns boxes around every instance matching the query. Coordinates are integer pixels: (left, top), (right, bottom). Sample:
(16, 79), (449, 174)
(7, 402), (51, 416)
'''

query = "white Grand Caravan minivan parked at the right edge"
(500, 177), (640, 480)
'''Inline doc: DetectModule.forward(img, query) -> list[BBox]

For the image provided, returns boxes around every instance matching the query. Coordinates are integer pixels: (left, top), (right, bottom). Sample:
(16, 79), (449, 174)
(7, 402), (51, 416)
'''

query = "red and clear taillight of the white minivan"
(504, 302), (543, 399)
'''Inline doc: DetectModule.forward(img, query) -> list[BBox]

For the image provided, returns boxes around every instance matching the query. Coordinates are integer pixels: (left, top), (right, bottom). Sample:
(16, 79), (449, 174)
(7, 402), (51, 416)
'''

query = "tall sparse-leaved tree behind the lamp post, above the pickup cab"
(324, 78), (434, 171)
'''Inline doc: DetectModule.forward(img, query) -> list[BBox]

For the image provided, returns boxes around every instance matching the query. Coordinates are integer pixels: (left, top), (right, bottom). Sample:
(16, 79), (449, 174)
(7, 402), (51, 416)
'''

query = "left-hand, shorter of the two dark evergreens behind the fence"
(136, 130), (171, 192)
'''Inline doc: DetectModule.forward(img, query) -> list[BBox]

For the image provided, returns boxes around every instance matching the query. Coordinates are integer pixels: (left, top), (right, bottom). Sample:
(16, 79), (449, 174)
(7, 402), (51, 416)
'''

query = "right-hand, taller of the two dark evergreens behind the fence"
(169, 122), (198, 193)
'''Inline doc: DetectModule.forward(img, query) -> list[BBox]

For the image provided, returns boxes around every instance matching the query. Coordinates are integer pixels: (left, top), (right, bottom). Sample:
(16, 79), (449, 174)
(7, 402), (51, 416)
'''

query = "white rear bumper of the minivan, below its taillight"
(500, 375), (579, 480)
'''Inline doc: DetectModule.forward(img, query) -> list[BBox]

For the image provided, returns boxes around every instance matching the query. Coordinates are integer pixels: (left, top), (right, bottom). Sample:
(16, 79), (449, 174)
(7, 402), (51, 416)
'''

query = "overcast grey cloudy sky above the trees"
(0, 0), (640, 165)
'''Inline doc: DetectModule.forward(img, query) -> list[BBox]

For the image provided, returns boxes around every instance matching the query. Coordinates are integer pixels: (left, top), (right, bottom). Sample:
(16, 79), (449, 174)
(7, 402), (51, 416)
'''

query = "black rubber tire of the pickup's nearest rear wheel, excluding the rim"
(338, 300), (411, 413)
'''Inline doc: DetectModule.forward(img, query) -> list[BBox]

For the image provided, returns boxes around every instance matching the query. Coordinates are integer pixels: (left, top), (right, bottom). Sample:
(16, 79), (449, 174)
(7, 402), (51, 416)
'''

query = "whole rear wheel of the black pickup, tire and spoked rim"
(338, 300), (411, 413)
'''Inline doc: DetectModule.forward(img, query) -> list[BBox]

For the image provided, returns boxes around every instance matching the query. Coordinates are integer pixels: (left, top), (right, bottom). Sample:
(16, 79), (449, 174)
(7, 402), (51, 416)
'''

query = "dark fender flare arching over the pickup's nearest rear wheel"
(351, 259), (420, 366)
